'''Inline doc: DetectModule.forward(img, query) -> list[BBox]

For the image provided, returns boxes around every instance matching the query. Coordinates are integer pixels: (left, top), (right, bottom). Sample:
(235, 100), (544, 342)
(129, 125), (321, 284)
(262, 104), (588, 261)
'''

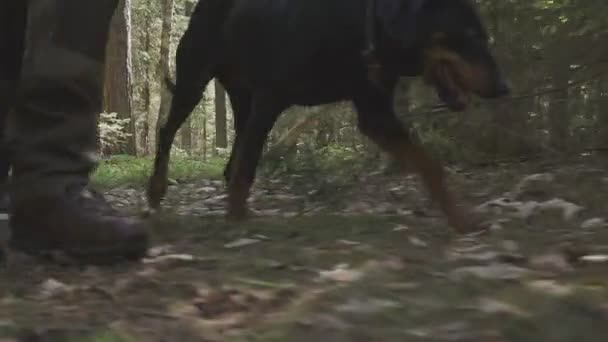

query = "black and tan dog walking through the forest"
(148, 0), (508, 231)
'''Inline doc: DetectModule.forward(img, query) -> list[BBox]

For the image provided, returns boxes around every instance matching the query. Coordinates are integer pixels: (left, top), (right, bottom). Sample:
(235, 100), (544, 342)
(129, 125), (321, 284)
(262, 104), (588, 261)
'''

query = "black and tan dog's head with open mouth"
(376, 0), (509, 110)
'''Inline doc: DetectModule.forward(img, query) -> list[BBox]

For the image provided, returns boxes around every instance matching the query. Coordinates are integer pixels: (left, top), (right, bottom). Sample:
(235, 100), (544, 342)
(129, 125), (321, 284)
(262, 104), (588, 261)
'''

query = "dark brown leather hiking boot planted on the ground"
(9, 189), (148, 264)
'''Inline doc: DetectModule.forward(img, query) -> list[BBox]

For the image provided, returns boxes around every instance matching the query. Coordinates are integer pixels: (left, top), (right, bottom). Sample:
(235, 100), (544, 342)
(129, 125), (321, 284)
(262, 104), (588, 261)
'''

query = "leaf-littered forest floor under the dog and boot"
(0, 156), (608, 342)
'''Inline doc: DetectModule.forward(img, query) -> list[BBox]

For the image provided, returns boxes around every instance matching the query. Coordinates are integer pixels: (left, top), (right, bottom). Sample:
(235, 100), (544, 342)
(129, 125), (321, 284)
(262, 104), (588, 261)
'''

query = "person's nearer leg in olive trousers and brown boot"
(8, 0), (148, 262)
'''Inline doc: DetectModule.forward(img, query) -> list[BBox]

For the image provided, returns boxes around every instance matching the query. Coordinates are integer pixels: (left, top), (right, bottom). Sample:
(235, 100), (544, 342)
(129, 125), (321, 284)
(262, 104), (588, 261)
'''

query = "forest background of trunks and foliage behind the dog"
(99, 0), (608, 186)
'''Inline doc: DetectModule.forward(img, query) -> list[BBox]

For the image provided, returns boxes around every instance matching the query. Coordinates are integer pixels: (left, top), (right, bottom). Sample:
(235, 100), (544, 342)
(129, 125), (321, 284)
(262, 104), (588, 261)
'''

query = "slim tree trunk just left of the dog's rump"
(155, 0), (175, 147)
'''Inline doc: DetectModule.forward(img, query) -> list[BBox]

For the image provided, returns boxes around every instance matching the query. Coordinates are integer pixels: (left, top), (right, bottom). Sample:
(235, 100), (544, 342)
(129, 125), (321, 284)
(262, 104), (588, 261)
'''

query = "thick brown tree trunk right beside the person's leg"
(104, 0), (137, 155)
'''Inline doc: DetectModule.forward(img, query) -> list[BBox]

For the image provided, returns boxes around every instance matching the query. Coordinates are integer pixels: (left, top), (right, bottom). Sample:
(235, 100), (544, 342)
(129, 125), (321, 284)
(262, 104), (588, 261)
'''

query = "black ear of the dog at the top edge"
(378, 0), (426, 46)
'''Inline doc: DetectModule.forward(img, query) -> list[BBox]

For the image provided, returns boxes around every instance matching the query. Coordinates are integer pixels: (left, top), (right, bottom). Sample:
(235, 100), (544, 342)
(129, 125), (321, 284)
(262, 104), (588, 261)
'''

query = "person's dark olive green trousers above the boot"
(0, 0), (118, 205)
